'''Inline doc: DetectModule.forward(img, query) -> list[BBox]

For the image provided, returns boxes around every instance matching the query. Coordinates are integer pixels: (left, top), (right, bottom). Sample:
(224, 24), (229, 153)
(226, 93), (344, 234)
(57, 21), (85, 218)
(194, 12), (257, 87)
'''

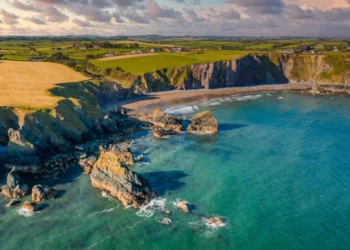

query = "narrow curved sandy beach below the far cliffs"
(113, 83), (312, 112)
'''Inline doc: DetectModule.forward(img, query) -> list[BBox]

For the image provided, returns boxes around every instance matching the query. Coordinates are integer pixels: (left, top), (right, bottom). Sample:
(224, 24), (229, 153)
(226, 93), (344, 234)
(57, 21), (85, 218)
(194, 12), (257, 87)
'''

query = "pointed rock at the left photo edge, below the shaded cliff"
(1, 168), (29, 198)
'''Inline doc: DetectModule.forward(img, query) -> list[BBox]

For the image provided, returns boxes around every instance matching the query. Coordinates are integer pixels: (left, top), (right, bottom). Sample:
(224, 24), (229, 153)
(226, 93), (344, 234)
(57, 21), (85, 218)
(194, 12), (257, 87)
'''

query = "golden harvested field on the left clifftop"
(0, 61), (87, 108)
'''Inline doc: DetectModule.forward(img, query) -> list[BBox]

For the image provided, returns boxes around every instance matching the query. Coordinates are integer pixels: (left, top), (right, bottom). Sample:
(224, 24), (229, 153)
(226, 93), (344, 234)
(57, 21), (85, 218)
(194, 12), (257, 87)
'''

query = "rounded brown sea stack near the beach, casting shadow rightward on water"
(187, 111), (219, 134)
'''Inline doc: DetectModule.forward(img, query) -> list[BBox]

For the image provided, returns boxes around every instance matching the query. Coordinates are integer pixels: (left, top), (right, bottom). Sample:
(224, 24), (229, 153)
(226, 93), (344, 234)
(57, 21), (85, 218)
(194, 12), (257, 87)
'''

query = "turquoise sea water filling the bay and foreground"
(0, 93), (350, 250)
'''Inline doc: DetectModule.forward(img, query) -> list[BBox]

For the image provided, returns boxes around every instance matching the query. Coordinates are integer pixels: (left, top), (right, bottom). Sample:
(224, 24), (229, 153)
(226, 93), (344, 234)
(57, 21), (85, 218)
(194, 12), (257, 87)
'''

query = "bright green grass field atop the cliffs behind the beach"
(91, 50), (249, 75)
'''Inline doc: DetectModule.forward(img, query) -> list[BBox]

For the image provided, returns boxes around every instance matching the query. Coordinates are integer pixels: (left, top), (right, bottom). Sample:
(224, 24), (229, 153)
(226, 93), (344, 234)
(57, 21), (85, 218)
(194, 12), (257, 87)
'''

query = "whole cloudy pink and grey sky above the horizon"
(0, 0), (350, 38)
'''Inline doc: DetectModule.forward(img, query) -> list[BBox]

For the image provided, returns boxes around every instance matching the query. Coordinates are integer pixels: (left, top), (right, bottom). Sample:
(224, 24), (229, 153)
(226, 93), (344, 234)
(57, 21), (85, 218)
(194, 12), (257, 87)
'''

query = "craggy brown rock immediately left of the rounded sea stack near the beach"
(152, 108), (184, 133)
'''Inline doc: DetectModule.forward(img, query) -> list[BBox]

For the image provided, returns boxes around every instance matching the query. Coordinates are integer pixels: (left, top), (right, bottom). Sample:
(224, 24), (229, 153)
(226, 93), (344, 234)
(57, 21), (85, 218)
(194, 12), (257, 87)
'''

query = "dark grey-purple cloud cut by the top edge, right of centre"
(230, 0), (285, 15)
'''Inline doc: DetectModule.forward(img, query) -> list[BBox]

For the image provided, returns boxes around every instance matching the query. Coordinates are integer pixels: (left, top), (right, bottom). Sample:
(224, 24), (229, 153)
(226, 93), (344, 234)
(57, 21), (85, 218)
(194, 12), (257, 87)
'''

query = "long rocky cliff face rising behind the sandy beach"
(137, 54), (350, 92)
